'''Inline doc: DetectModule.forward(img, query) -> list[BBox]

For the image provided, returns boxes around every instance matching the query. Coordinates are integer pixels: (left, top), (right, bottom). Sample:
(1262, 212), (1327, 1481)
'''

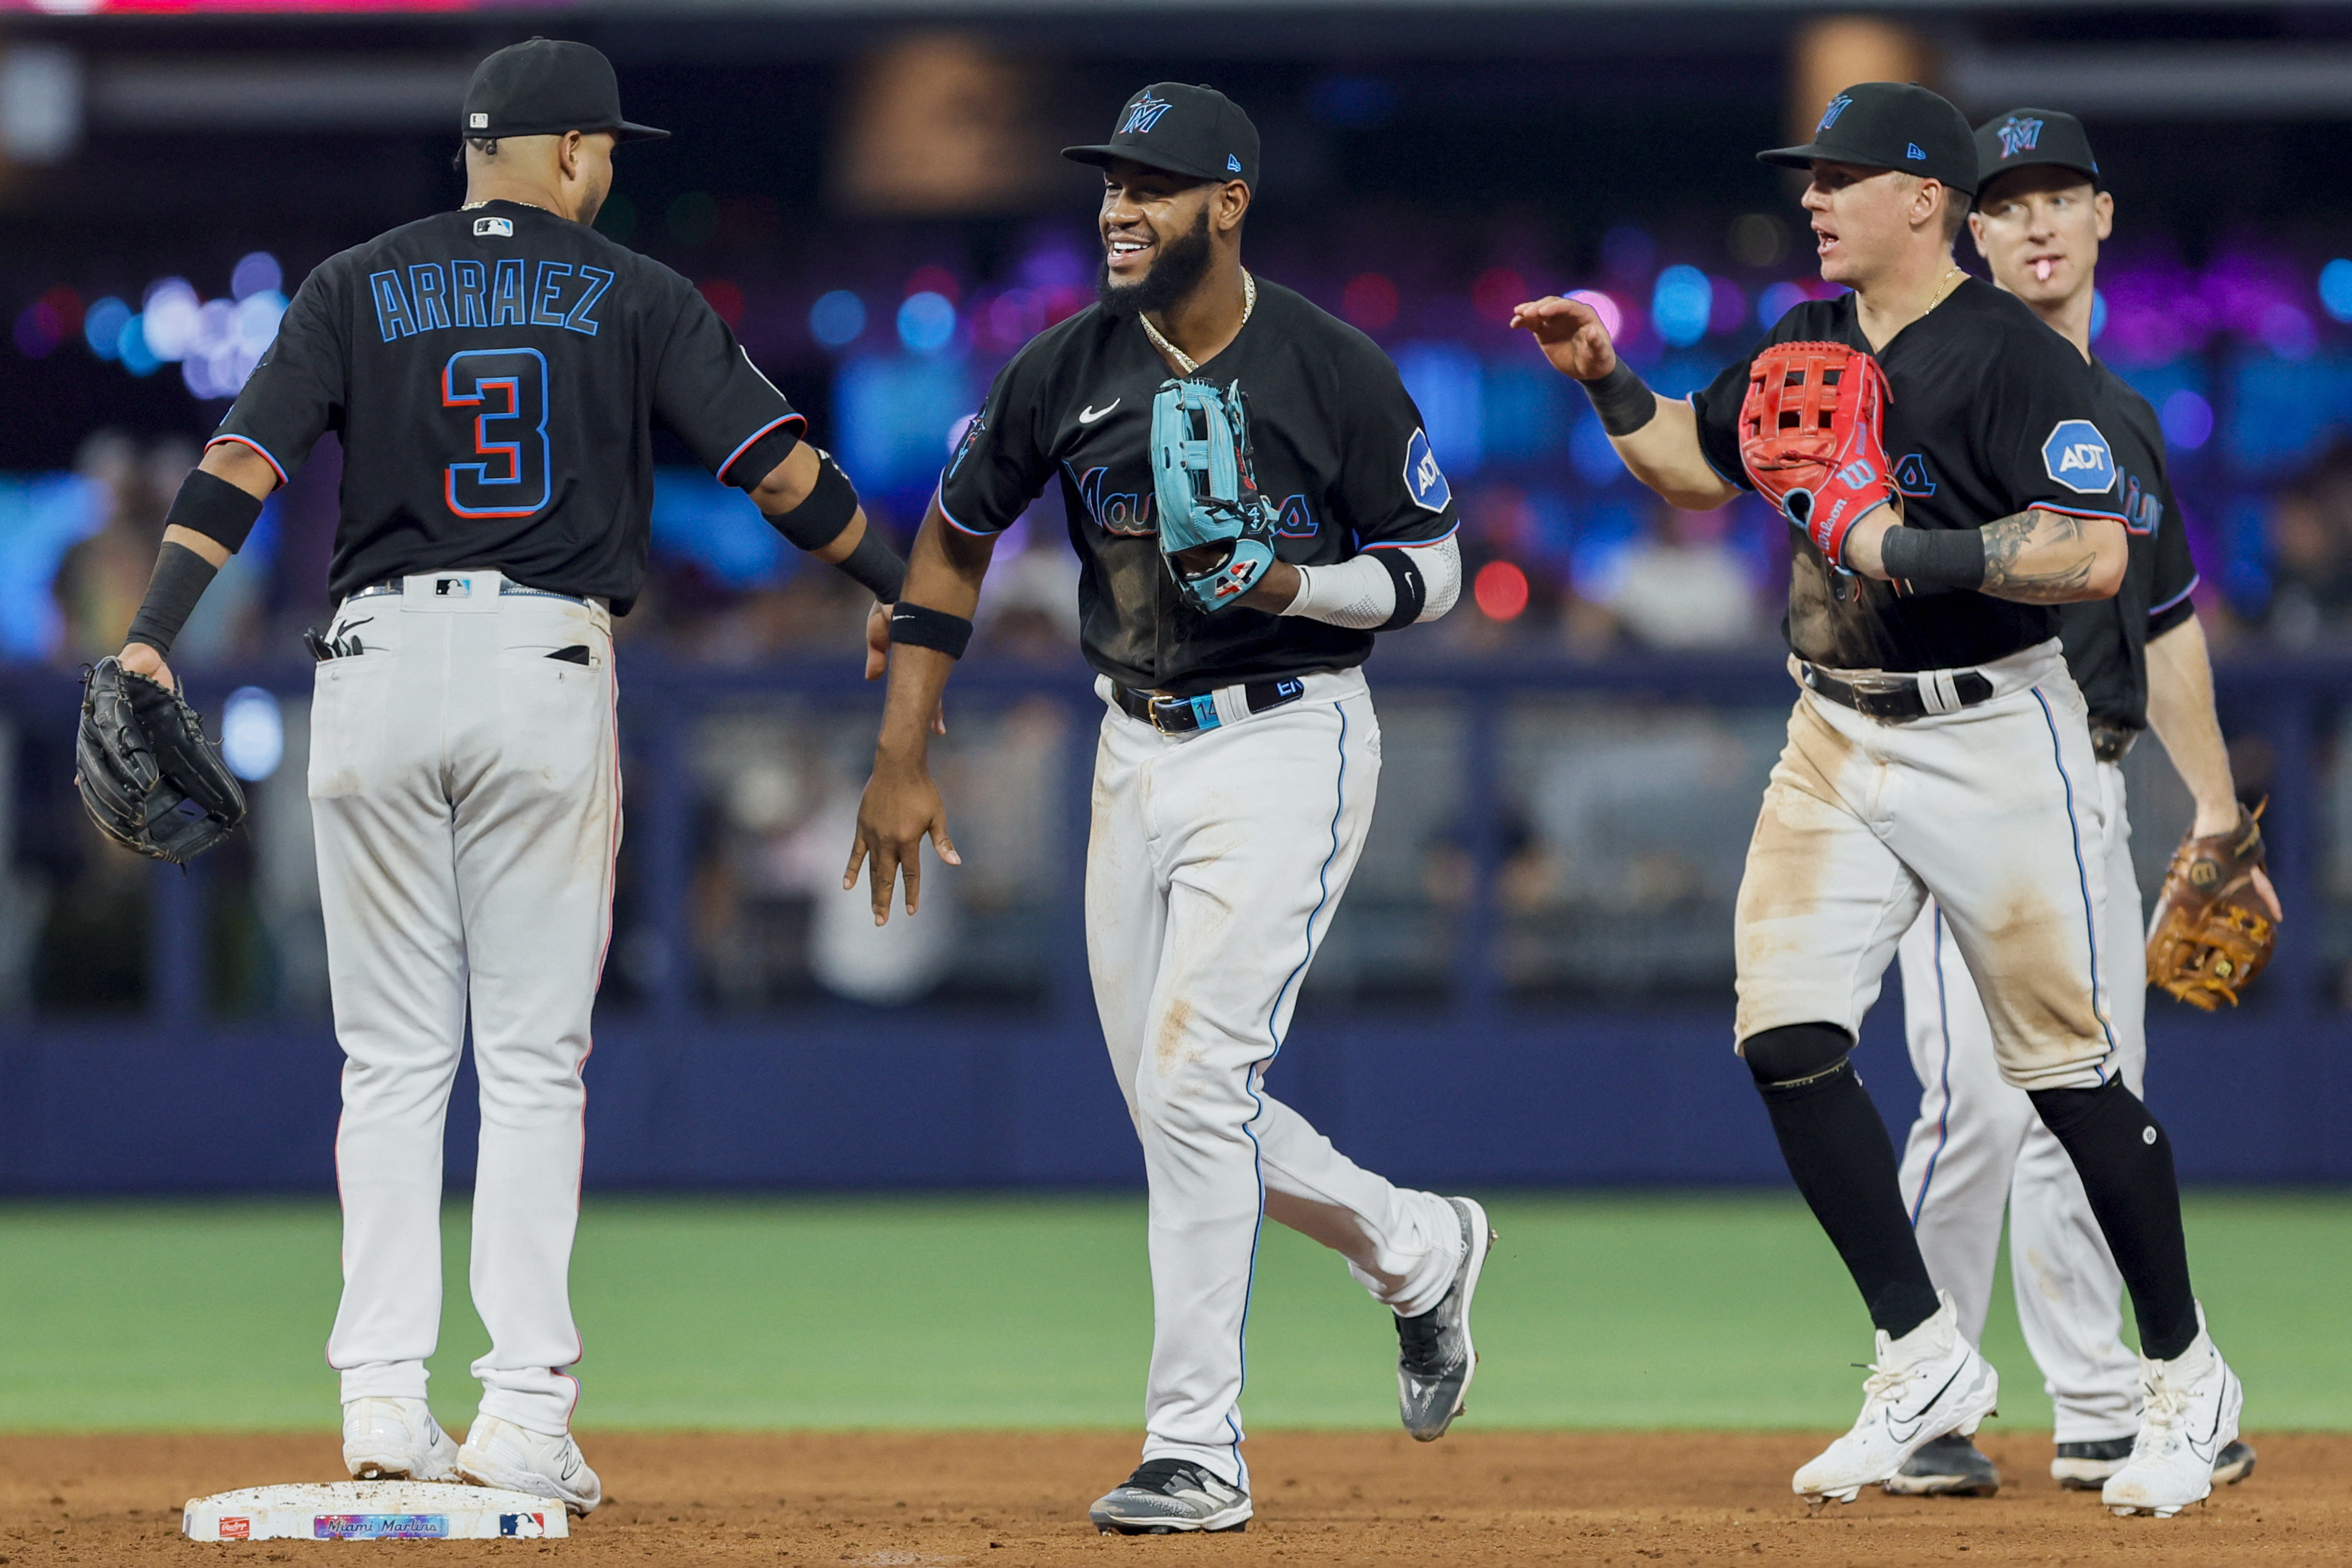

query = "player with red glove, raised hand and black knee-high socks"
(1515, 82), (2241, 1514)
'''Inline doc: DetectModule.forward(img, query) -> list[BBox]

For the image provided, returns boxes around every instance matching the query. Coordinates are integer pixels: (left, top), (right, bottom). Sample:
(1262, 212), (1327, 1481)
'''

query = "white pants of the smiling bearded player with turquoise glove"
(1087, 670), (1461, 1488)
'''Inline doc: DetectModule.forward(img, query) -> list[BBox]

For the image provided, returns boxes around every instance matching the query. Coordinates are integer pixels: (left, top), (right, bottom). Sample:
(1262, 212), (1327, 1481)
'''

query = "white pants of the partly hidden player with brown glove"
(1900, 762), (2147, 1444)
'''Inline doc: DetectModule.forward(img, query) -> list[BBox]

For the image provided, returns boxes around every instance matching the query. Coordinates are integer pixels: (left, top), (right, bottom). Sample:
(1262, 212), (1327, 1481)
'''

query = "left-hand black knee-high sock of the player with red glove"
(1740, 1023), (1938, 1340)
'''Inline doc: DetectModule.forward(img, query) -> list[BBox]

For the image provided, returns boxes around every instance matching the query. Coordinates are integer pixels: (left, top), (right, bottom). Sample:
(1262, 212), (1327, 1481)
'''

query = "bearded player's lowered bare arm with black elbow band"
(842, 498), (997, 926)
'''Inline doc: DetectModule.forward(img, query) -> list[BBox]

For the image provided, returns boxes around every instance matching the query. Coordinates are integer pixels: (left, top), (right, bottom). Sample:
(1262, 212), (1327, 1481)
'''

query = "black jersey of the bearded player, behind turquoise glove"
(938, 277), (1456, 696)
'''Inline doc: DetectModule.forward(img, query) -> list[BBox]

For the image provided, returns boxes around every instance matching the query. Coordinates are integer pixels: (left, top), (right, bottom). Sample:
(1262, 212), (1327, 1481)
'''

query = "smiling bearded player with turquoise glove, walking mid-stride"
(842, 82), (1489, 1535)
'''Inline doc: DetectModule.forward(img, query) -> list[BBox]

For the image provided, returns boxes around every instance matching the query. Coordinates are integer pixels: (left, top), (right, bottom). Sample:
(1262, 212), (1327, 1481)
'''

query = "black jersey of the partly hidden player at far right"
(2058, 360), (2197, 729)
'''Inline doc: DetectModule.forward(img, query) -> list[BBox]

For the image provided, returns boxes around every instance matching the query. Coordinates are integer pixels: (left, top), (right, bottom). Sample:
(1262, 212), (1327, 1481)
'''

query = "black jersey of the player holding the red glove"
(1691, 277), (2122, 670)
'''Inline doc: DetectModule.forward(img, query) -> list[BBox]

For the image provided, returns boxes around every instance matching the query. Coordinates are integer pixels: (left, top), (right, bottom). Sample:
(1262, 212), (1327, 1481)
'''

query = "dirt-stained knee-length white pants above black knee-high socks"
(1733, 637), (2117, 1088)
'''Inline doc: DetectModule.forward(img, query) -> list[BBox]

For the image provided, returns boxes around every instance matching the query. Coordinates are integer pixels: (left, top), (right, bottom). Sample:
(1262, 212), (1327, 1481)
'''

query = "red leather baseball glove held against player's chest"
(1740, 344), (1893, 567)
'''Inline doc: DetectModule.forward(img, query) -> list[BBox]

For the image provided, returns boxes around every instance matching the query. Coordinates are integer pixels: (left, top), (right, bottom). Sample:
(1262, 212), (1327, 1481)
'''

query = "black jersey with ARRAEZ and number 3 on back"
(211, 202), (804, 614)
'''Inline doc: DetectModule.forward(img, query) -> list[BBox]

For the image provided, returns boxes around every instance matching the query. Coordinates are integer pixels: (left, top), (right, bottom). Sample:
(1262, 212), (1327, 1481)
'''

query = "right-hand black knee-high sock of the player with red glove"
(2032, 1079), (2197, 1361)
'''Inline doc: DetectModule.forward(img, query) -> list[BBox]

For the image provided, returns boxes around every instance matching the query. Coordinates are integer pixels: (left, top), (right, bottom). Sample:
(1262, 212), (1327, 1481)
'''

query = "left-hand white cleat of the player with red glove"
(1794, 1291), (2001, 1504)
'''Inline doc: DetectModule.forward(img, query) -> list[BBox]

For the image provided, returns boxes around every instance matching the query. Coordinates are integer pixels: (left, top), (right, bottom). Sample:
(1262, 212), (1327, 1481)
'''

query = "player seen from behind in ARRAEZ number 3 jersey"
(105, 38), (903, 1514)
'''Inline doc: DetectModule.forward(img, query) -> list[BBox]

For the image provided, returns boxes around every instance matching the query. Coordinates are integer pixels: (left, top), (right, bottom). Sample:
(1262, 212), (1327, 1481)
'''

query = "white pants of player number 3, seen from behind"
(310, 571), (621, 1434)
